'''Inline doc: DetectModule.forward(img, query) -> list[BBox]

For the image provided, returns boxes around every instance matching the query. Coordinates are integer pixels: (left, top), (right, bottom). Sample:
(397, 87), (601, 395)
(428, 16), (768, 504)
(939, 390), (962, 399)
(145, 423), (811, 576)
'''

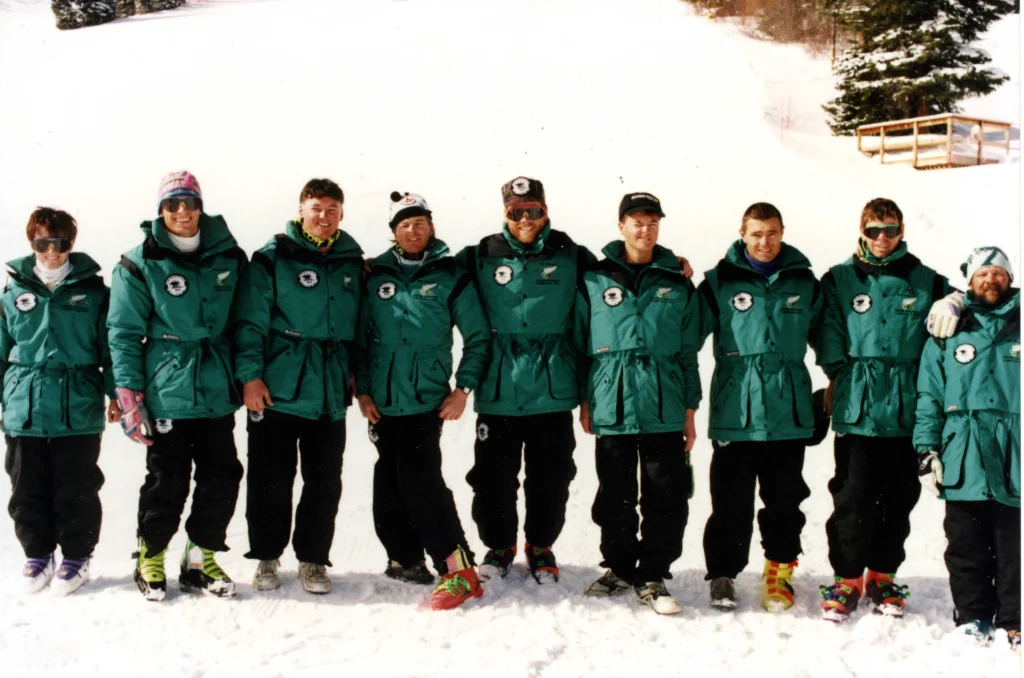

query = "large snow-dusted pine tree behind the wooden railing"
(822, 0), (1015, 134)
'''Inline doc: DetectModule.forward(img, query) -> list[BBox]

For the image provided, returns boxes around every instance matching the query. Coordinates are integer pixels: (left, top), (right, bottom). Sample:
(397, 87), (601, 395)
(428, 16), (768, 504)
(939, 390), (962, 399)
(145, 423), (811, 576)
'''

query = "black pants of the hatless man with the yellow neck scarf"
(246, 409), (345, 565)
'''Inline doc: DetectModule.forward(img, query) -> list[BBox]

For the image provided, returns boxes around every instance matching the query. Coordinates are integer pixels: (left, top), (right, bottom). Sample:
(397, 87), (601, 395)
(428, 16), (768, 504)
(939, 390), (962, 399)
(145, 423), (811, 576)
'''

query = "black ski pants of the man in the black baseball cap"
(591, 431), (693, 583)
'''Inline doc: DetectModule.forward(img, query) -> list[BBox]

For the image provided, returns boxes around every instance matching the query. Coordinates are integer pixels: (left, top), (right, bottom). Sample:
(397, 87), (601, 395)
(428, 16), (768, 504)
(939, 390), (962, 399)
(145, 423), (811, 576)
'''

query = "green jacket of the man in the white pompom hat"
(355, 240), (490, 416)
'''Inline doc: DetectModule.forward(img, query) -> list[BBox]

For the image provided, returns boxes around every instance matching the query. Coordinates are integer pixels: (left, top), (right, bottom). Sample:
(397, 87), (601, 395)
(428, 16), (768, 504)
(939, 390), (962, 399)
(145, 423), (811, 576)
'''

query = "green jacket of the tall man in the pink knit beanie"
(106, 214), (247, 419)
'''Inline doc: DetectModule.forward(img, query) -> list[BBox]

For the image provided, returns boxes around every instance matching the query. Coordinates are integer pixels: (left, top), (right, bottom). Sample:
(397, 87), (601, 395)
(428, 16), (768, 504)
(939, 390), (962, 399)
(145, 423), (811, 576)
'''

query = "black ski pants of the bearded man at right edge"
(943, 500), (1021, 631)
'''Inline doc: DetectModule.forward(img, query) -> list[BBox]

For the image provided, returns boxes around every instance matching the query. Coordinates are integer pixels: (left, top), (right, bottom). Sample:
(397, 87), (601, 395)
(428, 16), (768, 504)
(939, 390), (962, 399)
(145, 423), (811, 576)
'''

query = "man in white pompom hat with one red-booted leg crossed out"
(355, 192), (490, 609)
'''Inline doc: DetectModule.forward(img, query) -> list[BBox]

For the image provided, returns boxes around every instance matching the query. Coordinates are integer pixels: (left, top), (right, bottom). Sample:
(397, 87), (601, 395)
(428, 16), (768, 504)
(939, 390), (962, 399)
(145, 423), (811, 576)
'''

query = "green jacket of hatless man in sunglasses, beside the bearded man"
(817, 243), (951, 437)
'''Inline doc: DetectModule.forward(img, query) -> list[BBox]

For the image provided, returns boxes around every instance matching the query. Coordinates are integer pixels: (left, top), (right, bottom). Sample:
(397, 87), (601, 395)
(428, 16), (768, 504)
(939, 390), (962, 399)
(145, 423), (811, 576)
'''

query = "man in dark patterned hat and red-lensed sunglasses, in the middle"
(457, 176), (593, 583)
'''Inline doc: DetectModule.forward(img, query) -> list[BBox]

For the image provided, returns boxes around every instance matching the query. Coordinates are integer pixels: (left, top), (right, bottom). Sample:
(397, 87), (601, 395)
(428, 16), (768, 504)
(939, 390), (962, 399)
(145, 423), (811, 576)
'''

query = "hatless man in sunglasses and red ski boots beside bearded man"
(817, 198), (950, 622)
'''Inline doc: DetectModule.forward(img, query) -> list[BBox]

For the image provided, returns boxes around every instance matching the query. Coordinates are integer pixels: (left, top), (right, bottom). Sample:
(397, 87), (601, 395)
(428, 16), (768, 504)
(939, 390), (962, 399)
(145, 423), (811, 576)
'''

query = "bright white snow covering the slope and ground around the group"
(0, 0), (1020, 678)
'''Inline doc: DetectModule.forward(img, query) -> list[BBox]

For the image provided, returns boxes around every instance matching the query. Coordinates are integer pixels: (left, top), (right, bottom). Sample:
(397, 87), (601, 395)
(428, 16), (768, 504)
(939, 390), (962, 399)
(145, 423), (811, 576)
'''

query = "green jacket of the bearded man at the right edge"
(913, 290), (1021, 508)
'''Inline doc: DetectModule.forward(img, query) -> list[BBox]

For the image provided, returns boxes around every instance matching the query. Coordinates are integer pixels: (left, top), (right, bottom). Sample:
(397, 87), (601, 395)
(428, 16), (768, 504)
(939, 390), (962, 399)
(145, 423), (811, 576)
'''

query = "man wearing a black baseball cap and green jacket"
(573, 193), (700, 615)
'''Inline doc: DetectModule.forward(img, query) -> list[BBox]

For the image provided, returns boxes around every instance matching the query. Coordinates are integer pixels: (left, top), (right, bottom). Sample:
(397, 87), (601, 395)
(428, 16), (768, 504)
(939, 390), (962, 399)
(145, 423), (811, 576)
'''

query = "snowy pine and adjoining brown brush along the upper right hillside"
(686, 0), (1020, 134)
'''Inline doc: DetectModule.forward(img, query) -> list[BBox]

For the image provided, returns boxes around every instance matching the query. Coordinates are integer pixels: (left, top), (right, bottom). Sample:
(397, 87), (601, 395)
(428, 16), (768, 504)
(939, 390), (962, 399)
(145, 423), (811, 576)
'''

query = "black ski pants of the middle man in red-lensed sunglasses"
(466, 412), (577, 549)
